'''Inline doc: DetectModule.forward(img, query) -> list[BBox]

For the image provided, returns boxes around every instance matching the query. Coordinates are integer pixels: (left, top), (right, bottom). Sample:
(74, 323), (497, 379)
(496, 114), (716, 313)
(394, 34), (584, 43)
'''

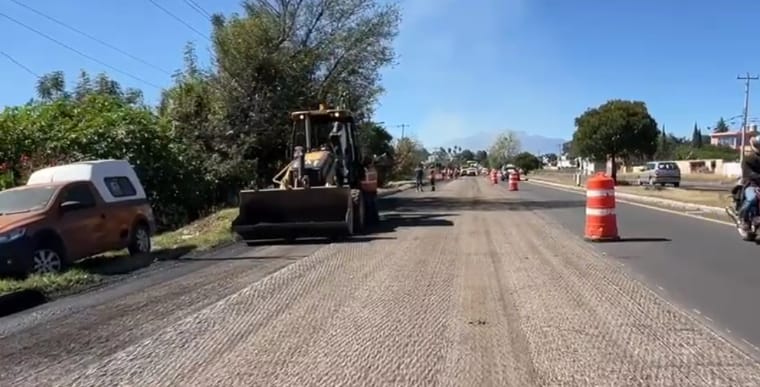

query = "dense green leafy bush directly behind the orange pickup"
(0, 95), (214, 229)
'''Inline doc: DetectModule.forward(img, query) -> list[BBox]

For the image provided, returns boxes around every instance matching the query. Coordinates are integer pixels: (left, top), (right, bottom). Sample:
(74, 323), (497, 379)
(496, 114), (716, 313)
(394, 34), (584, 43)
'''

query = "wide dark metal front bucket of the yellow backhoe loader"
(232, 187), (351, 240)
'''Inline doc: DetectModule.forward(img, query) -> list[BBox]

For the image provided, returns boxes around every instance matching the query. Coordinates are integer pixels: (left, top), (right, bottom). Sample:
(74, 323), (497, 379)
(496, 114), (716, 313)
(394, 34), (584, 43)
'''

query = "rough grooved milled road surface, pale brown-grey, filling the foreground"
(0, 177), (760, 387)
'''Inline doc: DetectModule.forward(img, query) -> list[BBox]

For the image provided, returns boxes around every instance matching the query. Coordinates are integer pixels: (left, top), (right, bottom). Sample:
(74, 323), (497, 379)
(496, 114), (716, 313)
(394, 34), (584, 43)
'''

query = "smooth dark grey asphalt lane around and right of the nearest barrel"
(519, 179), (760, 355)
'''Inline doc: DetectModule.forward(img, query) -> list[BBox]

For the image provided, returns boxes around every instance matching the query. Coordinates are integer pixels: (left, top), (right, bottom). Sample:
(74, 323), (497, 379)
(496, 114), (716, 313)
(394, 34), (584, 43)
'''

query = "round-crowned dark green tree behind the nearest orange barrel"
(572, 100), (660, 183)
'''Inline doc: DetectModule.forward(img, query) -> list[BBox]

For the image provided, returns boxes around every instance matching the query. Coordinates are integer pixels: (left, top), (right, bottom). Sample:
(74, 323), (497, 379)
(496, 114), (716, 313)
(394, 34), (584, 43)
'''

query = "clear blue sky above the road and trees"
(0, 0), (760, 146)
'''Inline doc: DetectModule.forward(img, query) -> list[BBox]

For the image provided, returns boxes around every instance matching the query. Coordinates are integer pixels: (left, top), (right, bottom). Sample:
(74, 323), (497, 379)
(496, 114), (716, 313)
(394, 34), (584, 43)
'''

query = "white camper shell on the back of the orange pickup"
(26, 160), (146, 203)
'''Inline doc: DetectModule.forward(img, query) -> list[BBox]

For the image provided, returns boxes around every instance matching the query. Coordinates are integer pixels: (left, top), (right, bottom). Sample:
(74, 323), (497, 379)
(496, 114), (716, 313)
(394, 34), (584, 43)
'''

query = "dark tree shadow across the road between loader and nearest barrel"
(380, 197), (586, 212)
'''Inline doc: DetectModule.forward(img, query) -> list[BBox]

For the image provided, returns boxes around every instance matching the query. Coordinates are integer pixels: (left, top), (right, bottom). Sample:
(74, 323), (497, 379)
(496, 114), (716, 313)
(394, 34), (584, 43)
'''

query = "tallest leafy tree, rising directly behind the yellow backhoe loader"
(197, 0), (399, 182)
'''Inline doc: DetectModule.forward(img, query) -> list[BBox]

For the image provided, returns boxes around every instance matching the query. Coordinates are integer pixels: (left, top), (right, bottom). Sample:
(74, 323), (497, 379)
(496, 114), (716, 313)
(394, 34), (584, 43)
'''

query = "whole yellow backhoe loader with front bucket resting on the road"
(232, 105), (379, 241)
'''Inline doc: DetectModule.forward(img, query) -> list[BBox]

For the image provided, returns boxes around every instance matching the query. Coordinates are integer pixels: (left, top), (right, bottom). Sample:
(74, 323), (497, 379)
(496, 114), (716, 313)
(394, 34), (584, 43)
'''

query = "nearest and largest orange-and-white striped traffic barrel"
(584, 172), (620, 242)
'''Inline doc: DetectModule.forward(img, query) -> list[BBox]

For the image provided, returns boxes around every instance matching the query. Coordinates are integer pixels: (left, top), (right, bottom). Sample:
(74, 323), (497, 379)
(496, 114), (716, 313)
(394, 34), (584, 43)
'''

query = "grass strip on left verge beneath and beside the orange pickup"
(0, 208), (237, 295)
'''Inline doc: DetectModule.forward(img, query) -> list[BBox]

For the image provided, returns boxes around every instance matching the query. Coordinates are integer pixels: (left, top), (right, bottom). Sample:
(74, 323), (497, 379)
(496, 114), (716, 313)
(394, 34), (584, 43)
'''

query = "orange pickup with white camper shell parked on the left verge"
(0, 160), (155, 274)
